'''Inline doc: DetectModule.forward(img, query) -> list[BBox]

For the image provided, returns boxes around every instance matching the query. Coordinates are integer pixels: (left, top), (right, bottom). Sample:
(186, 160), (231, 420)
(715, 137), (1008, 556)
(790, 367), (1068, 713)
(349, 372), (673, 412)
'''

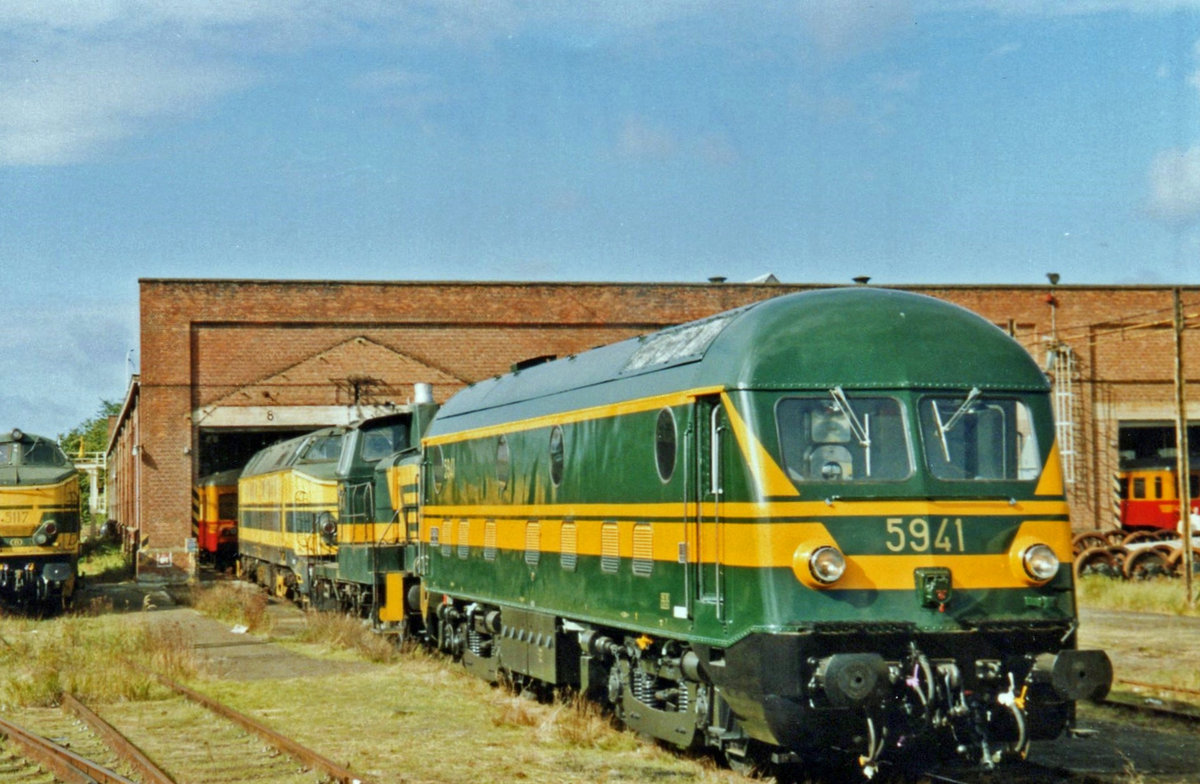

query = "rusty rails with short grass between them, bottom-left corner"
(0, 676), (367, 784)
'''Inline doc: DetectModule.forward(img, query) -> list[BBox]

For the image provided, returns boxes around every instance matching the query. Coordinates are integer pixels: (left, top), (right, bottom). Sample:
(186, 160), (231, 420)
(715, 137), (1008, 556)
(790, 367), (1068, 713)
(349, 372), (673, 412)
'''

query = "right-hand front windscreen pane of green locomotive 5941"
(919, 389), (1042, 481)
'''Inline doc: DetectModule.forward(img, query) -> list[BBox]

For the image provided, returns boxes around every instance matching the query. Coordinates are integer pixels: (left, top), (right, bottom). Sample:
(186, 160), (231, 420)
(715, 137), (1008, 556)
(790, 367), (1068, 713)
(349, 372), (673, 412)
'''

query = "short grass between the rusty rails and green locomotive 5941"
(196, 650), (745, 784)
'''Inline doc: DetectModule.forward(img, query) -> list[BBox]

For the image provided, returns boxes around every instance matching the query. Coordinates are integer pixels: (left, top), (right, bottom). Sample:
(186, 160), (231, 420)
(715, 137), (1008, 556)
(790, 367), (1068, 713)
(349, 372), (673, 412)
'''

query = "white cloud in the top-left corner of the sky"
(0, 0), (348, 166)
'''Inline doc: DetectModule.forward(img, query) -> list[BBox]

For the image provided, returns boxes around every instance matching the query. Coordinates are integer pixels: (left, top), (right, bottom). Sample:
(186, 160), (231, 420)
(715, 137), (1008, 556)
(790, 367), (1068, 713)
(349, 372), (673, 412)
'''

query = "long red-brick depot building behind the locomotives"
(108, 280), (1200, 580)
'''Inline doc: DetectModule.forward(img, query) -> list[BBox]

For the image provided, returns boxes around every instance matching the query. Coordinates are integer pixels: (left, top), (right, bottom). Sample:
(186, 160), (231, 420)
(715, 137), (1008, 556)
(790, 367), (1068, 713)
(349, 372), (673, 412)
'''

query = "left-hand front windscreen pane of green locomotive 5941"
(775, 388), (912, 481)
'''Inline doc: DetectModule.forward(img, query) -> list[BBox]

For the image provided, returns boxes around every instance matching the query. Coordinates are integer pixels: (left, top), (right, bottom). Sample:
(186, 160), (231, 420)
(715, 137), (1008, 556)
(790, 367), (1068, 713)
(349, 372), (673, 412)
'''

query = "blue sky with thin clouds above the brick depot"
(0, 0), (1200, 435)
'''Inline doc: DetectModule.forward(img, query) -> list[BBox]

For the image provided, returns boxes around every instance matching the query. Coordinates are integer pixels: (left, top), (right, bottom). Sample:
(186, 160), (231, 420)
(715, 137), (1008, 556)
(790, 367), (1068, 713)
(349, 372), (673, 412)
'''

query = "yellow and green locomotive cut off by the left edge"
(0, 430), (79, 610)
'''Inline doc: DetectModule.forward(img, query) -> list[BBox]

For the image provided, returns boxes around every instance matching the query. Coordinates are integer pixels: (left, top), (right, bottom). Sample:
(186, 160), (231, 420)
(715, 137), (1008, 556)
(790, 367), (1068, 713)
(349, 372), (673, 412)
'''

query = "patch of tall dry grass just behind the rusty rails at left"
(0, 616), (197, 707)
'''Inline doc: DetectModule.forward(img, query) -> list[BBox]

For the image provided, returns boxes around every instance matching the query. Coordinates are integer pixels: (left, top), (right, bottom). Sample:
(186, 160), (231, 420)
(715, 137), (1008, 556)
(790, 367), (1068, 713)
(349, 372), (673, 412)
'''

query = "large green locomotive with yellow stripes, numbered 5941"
(421, 288), (1111, 773)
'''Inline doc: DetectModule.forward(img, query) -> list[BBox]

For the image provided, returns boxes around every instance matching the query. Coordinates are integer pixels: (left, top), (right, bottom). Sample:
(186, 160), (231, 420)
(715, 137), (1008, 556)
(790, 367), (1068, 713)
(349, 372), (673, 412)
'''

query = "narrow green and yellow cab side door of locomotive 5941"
(692, 395), (730, 622)
